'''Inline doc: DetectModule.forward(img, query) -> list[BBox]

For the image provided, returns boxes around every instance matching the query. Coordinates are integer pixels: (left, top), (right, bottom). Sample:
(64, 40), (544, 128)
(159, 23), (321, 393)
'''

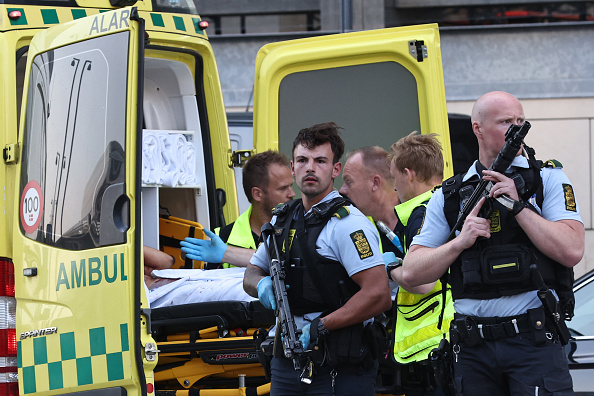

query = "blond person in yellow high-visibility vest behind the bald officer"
(387, 132), (454, 396)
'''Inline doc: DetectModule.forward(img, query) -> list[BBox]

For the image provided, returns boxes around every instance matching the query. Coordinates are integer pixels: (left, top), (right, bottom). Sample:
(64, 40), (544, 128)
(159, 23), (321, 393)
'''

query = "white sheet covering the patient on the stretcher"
(148, 268), (256, 308)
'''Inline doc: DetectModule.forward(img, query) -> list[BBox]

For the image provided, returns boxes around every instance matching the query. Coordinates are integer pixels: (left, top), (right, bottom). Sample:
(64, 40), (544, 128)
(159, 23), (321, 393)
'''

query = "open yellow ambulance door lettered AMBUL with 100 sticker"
(13, 8), (156, 396)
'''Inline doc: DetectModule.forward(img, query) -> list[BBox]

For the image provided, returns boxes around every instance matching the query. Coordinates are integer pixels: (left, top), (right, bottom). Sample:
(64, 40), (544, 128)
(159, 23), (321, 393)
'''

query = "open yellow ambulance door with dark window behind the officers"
(254, 24), (452, 181)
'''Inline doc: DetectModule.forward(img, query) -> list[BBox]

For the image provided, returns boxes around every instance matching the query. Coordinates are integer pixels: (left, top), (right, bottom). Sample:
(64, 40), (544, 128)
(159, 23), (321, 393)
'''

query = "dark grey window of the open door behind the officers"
(278, 62), (421, 173)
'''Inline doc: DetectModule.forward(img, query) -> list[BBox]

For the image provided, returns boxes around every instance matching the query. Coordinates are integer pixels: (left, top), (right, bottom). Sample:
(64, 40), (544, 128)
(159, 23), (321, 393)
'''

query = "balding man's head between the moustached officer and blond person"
(339, 146), (404, 258)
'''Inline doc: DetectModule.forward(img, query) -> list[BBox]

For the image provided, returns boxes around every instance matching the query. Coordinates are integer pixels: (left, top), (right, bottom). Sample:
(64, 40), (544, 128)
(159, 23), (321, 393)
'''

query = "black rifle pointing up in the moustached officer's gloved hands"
(262, 223), (312, 384)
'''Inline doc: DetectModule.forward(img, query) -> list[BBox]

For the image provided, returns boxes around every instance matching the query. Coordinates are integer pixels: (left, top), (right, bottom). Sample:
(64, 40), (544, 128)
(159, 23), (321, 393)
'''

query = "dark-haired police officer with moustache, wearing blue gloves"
(244, 123), (391, 395)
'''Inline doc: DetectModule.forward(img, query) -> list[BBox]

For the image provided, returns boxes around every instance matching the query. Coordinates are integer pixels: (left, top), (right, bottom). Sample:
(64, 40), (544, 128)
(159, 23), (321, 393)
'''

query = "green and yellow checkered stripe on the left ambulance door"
(17, 323), (131, 394)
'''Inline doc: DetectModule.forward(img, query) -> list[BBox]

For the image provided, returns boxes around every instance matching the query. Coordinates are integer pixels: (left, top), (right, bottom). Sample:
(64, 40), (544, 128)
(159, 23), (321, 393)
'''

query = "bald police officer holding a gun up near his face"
(402, 91), (584, 395)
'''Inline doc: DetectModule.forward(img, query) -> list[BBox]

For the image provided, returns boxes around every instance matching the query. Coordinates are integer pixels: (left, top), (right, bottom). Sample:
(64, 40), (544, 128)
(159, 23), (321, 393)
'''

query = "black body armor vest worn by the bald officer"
(442, 161), (573, 316)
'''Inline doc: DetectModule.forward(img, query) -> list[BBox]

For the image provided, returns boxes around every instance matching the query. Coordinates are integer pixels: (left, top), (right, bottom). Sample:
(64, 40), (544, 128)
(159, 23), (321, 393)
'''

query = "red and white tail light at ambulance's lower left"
(0, 259), (19, 396)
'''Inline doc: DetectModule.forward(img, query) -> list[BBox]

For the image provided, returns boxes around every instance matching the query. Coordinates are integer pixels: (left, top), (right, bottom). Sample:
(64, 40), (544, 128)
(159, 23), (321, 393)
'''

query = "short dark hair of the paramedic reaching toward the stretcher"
(241, 150), (289, 203)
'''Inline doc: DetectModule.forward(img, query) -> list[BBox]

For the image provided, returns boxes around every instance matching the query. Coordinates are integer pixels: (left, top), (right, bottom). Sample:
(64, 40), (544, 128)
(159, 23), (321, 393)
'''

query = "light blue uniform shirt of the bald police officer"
(411, 156), (583, 317)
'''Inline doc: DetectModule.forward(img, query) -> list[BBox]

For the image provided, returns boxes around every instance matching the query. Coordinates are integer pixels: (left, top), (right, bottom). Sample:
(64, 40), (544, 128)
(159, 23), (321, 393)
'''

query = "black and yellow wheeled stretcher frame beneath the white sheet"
(151, 301), (275, 396)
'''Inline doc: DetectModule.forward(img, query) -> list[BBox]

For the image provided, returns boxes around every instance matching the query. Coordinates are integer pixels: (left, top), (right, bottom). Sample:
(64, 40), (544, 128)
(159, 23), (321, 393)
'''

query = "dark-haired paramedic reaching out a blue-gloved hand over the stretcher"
(180, 150), (295, 268)
